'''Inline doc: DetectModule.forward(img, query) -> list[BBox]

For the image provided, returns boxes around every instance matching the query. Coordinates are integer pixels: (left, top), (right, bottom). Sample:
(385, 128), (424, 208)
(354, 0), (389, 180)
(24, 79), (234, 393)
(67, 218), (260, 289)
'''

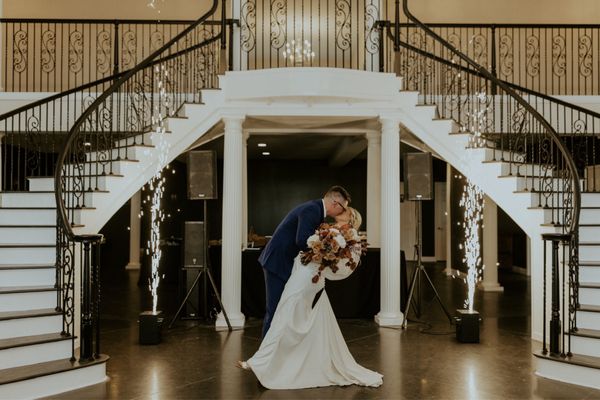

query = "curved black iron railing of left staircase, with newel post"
(54, 0), (225, 360)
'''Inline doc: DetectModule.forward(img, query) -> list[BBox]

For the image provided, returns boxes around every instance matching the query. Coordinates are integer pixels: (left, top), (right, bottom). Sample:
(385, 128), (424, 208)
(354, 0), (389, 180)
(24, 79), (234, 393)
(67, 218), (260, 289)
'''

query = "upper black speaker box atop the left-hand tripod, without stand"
(187, 150), (218, 200)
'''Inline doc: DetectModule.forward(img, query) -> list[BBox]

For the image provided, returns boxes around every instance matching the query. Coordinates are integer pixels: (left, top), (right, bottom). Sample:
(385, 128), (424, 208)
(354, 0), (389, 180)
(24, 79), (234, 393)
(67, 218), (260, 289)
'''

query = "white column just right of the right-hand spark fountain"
(479, 195), (504, 292)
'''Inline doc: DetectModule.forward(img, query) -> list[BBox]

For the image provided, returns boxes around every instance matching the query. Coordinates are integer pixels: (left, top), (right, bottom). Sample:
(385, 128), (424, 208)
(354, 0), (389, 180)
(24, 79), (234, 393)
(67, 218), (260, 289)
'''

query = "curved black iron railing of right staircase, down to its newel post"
(388, 0), (581, 354)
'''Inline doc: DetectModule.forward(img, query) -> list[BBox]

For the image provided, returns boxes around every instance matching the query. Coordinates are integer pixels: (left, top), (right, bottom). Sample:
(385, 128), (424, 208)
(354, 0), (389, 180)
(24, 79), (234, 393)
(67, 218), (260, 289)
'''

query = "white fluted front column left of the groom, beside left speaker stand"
(216, 116), (244, 329)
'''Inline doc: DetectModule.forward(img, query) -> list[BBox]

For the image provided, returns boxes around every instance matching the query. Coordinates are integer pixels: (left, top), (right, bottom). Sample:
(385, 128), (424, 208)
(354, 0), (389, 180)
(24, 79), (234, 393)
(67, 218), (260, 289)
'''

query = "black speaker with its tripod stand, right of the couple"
(402, 153), (452, 329)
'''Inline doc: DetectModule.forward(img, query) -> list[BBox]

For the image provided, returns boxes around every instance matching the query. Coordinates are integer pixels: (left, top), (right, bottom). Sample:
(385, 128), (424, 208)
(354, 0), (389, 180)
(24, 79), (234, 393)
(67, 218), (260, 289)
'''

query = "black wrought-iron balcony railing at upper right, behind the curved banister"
(400, 23), (600, 95)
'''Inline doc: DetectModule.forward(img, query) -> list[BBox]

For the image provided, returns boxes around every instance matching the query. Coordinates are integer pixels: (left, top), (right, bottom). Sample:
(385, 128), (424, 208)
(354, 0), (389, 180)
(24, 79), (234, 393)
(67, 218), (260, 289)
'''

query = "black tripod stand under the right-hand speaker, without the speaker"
(402, 199), (452, 329)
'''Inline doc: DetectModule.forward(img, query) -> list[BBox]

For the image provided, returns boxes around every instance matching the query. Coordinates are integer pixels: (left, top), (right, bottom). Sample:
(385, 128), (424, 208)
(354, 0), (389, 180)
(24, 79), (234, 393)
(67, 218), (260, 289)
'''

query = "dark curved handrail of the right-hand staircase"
(404, 0), (581, 235)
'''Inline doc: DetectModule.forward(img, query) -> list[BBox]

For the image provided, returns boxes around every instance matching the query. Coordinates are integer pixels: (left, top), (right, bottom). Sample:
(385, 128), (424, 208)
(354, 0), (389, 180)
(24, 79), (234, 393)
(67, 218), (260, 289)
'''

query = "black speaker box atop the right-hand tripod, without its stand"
(404, 153), (433, 200)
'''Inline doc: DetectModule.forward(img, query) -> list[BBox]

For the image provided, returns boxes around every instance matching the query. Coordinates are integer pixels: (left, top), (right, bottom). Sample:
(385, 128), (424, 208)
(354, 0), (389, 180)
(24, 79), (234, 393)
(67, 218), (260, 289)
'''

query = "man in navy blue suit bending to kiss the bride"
(258, 186), (350, 337)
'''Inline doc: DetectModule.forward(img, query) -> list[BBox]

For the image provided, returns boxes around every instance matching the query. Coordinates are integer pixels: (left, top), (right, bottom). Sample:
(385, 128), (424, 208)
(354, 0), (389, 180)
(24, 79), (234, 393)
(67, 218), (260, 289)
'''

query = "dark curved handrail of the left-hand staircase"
(54, 0), (220, 241)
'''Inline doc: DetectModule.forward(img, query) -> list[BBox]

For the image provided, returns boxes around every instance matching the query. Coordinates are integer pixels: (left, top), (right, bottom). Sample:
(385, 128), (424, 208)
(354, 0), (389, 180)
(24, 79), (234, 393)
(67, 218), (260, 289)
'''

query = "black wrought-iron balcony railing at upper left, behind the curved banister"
(0, 18), (202, 92)
